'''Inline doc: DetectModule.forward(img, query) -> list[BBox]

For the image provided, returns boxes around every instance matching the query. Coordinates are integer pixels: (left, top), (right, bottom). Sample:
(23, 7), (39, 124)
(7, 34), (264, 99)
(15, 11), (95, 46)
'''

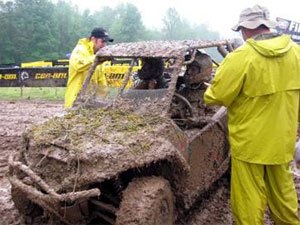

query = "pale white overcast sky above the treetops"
(63, 0), (300, 38)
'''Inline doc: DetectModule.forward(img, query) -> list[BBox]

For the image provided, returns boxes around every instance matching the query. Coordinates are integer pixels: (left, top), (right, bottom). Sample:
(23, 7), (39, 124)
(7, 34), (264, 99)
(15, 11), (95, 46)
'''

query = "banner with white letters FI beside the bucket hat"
(276, 17), (300, 44)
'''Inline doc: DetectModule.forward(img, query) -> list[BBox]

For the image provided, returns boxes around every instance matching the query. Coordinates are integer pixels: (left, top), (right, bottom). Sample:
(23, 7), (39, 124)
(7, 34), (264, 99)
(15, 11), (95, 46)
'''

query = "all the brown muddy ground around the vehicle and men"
(0, 101), (300, 225)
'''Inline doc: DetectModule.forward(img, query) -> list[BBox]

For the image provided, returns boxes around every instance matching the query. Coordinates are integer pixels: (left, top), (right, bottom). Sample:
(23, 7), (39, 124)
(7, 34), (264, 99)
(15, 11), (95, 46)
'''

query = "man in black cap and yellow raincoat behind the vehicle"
(65, 27), (113, 108)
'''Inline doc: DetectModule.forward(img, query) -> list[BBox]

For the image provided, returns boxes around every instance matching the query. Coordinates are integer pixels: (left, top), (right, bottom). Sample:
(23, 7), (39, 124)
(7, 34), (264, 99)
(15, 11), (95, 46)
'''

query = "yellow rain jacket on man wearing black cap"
(65, 38), (107, 108)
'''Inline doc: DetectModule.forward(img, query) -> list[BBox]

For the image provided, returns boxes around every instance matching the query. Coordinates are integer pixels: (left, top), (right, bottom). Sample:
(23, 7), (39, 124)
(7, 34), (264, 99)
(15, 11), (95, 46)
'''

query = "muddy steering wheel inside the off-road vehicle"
(171, 93), (194, 127)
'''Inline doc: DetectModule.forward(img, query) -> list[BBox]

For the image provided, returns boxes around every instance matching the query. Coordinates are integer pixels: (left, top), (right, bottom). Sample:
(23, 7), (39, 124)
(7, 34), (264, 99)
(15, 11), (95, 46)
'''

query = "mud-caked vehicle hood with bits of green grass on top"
(23, 109), (187, 191)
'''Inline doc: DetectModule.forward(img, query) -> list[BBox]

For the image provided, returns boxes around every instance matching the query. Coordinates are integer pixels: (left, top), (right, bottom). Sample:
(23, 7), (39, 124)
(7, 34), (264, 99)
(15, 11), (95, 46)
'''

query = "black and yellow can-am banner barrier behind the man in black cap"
(0, 59), (141, 87)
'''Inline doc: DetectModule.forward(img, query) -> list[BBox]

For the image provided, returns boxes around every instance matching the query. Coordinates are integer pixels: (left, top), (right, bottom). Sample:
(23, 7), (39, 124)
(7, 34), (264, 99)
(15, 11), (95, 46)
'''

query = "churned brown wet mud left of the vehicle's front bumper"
(0, 101), (63, 225)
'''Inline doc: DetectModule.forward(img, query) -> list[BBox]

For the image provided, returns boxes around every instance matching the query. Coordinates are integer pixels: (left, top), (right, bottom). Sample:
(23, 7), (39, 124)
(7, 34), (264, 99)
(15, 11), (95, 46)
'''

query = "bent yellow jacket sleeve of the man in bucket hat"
(204, 53), (245, 107)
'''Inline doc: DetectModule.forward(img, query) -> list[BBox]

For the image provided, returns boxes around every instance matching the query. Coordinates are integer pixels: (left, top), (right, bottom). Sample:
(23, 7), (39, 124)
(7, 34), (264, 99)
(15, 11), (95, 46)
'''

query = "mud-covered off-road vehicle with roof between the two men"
(8, 41), (229, 225)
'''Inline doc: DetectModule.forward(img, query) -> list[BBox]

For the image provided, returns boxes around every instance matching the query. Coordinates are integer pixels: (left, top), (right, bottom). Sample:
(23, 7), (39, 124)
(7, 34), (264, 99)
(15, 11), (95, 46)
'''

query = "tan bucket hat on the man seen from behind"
(232, 5), (277, 31)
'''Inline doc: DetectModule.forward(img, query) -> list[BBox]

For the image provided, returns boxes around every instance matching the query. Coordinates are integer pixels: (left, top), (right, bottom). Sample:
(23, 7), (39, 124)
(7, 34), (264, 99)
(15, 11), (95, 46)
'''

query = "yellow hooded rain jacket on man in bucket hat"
(204, 35), (300, 164)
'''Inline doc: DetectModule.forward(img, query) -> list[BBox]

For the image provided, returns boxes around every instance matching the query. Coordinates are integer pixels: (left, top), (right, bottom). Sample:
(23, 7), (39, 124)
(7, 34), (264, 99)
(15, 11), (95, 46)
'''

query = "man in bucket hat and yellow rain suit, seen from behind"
(204, 5), (300, 225)
